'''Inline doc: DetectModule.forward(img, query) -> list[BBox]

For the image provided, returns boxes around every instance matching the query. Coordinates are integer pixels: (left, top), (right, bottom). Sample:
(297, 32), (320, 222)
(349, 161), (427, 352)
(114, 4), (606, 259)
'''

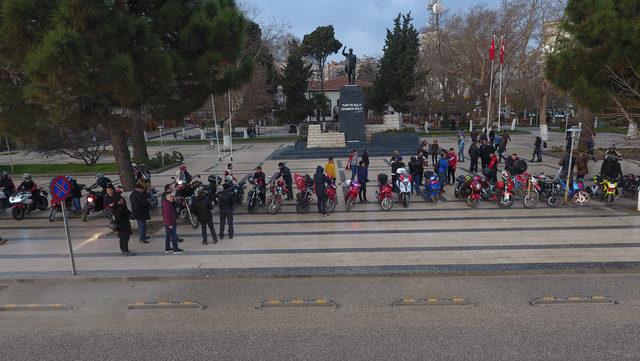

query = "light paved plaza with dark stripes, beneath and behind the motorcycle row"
(0, 129), (640, 278)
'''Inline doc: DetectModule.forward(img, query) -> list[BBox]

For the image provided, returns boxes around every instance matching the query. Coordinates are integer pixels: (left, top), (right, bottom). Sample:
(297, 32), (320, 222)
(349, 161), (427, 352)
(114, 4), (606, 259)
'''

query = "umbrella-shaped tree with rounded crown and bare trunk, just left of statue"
(301, 25), (342, 121)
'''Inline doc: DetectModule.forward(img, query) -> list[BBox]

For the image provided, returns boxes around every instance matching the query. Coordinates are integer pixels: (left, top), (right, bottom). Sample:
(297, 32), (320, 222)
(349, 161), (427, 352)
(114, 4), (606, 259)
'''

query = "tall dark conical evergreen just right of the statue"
(368, 13), (419, 112)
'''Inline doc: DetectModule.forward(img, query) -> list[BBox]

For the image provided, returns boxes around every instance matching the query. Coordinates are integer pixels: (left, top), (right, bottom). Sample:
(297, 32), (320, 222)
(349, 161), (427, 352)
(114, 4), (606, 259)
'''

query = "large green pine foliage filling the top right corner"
(545, 0), (640, 133)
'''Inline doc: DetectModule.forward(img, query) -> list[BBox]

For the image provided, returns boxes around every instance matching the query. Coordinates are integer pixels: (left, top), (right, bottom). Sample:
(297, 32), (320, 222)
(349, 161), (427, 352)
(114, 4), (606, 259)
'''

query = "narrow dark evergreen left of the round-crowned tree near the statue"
(279, 40), (311, 123)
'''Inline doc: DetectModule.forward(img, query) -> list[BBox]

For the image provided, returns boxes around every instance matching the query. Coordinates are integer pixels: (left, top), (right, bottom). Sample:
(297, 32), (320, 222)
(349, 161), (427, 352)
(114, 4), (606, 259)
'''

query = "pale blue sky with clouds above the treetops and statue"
(244, 0), (500, 60)
